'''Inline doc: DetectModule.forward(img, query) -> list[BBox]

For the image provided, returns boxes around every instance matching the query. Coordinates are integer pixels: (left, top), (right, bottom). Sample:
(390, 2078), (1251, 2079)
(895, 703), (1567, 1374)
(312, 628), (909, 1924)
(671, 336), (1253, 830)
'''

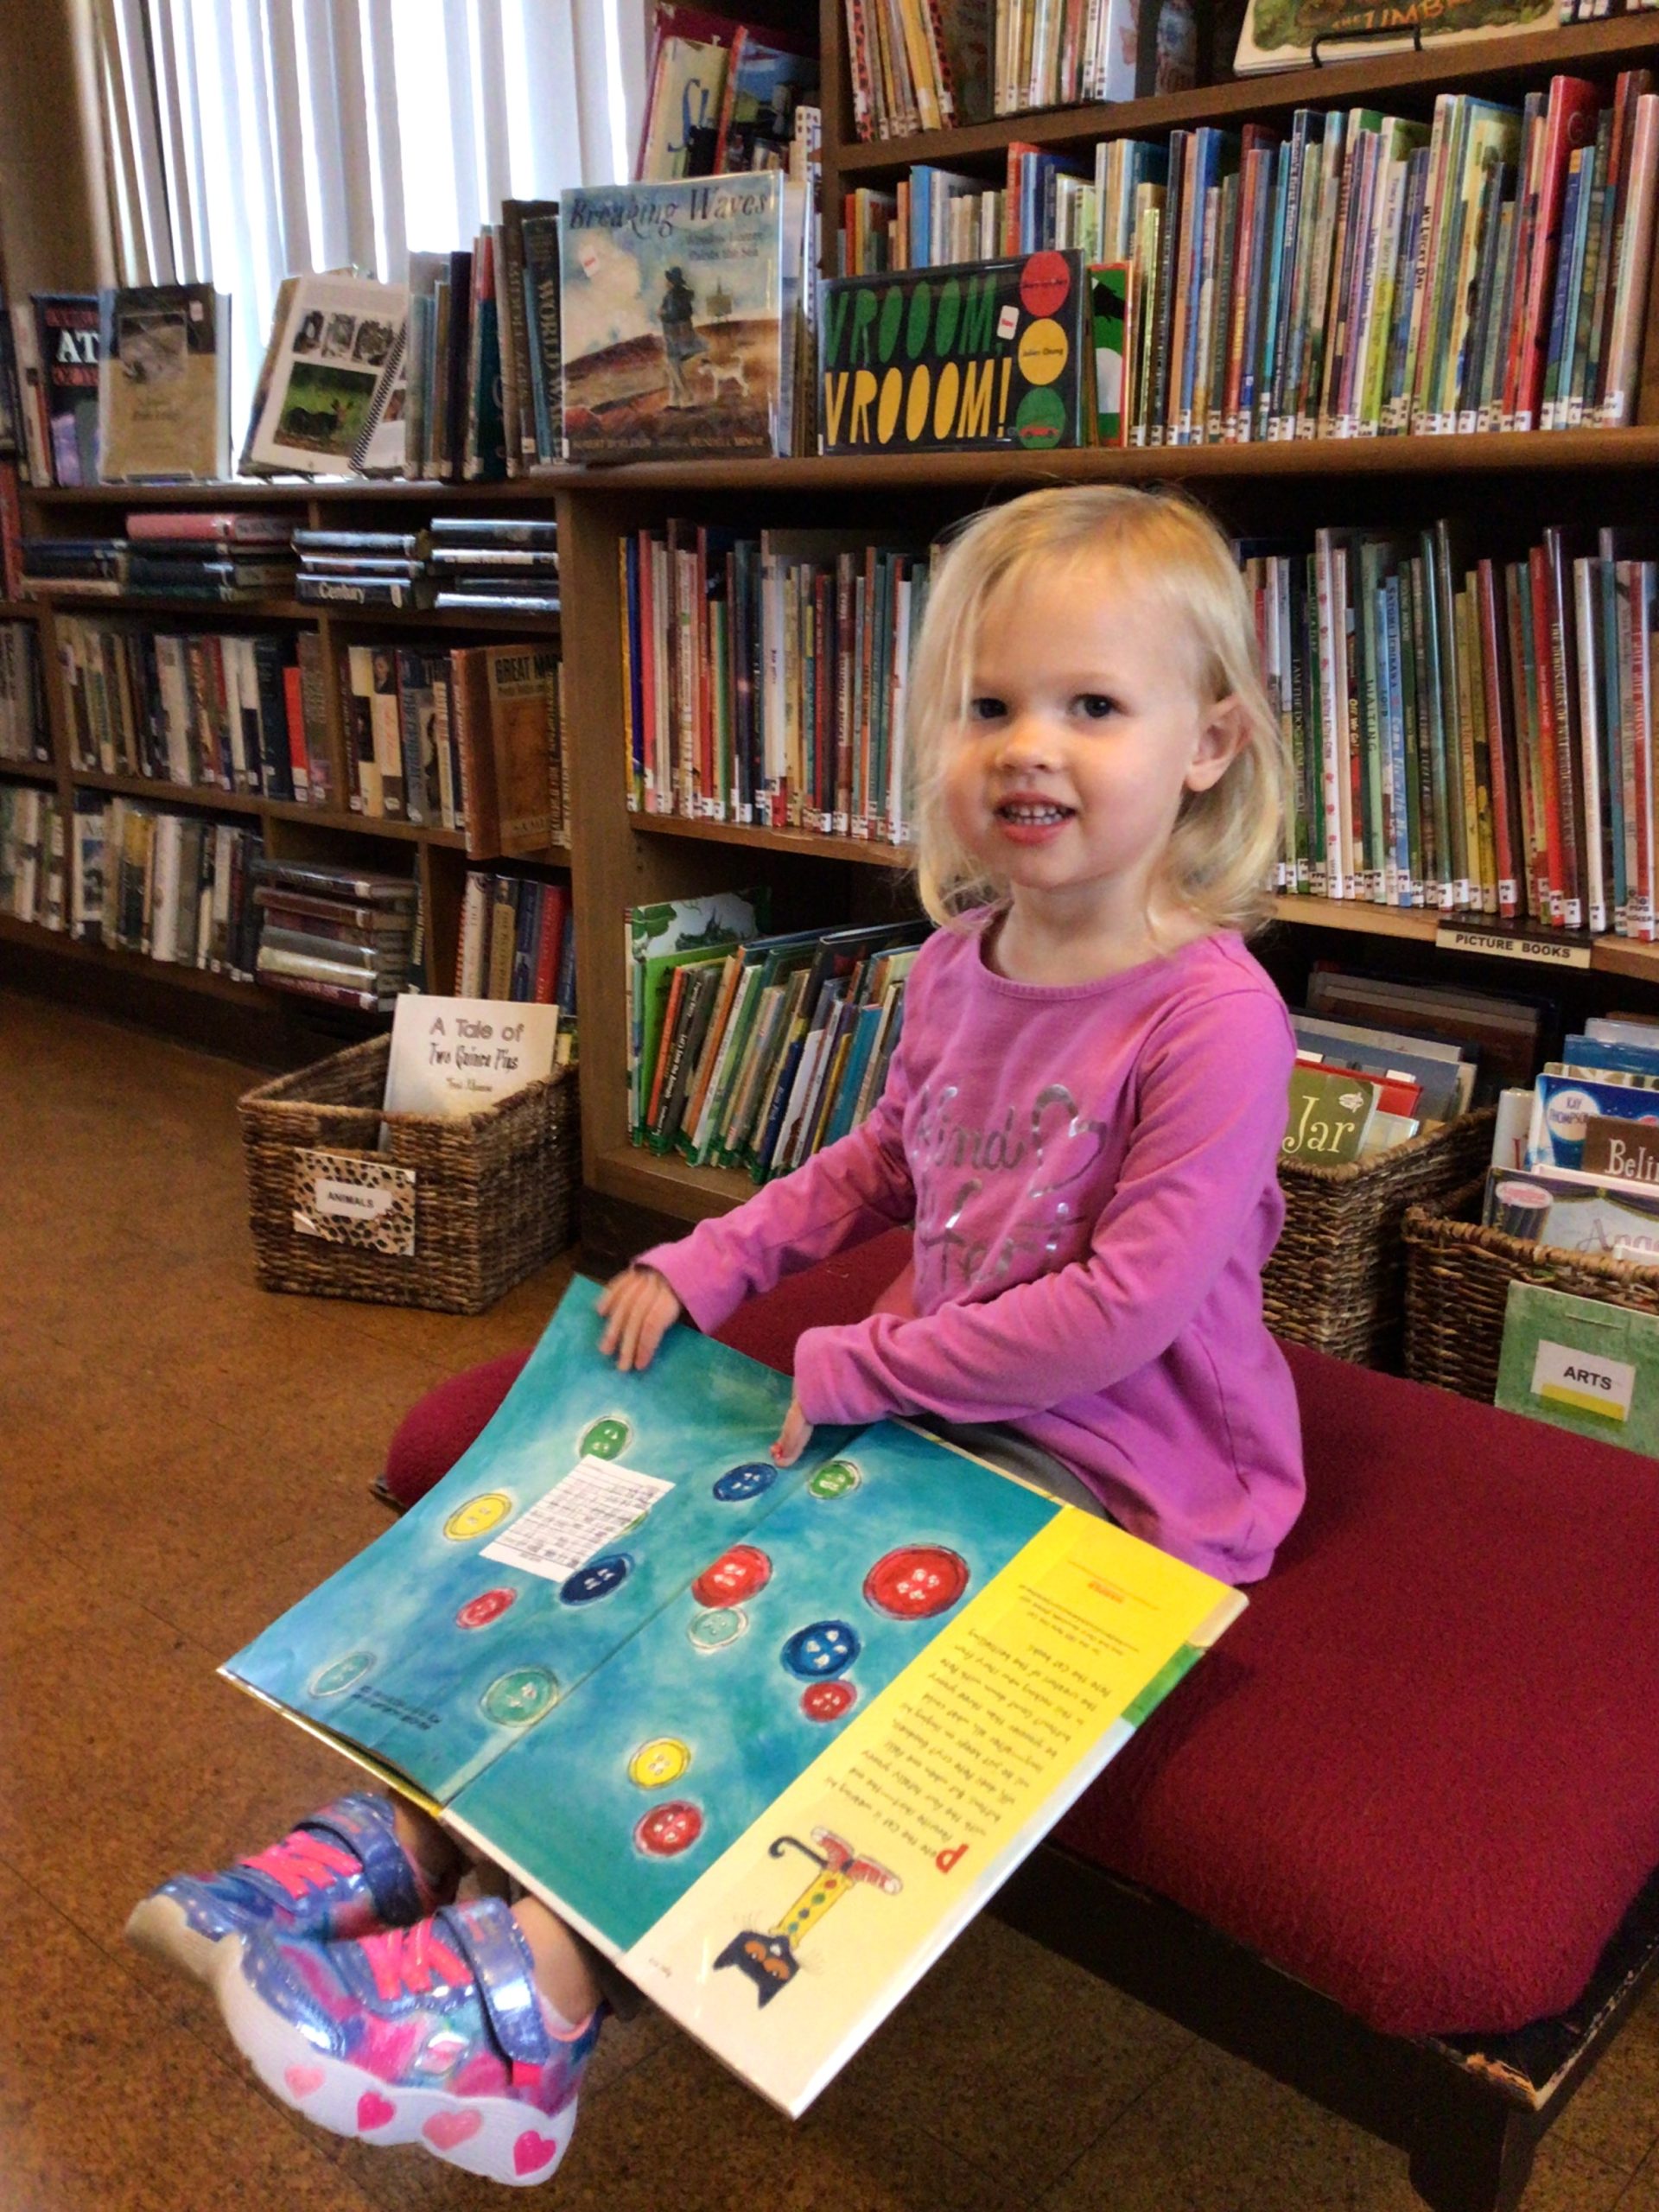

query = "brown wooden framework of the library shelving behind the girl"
(0, 0), (1659, 1252)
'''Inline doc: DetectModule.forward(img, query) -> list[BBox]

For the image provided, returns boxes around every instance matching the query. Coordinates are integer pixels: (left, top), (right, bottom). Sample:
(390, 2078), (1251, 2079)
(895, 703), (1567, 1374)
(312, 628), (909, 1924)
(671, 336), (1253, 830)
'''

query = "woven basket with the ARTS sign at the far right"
(1402, 1177), (1659, 1405)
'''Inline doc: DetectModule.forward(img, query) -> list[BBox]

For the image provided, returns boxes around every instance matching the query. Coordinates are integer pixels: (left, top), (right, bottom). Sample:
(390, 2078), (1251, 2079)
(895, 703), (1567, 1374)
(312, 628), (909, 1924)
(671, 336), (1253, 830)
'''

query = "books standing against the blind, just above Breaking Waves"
(632, 0), (818, 183)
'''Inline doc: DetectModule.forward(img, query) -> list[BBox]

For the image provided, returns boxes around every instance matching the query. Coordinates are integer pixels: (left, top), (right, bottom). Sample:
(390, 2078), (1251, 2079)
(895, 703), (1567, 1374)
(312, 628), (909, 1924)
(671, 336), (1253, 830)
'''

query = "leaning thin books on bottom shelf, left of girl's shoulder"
(628, 893), (927, 1184)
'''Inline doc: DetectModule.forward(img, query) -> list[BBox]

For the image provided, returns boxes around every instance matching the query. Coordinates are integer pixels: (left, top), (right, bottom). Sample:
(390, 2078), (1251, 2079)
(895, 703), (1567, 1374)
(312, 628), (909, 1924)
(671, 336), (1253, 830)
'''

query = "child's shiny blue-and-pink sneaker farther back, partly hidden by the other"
(126, 1789), (442, 1982)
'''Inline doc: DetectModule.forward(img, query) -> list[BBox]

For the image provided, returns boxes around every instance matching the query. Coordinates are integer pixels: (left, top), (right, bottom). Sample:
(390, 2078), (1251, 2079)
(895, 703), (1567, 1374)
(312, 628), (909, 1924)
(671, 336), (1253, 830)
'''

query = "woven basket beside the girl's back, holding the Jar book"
(1263, 1109), (1496, 1370)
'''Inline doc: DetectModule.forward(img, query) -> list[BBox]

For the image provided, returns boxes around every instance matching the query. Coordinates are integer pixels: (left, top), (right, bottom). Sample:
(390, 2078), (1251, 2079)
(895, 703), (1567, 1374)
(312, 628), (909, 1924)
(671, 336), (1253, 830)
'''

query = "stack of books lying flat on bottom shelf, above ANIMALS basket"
(254, 861), (416, 1013)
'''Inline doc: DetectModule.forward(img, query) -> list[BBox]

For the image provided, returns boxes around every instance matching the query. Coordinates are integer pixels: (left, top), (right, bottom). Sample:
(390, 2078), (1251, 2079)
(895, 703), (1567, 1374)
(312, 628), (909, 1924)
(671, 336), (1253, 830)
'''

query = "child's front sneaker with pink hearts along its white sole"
(214, 1897), (600, 2183)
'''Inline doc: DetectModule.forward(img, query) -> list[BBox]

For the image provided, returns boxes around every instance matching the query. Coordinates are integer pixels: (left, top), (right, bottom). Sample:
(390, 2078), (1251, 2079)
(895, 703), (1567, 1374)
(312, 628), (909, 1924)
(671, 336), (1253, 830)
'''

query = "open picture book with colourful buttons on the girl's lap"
(224, 1281), (1243, 2114)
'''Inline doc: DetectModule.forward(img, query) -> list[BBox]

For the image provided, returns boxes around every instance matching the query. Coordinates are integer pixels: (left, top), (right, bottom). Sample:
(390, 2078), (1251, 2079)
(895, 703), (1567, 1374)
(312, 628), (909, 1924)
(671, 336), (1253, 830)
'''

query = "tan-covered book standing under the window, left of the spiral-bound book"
(98, 283), (230, 482)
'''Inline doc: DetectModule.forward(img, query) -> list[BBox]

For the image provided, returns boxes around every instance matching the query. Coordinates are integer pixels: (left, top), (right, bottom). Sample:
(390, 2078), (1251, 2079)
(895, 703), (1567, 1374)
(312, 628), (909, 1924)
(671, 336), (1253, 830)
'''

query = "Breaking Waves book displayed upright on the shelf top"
(560, 170), (805, 460)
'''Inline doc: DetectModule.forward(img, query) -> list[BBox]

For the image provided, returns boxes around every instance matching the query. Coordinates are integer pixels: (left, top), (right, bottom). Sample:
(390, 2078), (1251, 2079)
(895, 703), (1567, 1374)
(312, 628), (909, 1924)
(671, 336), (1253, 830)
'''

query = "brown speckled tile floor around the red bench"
(0, 991), (1659, 2212)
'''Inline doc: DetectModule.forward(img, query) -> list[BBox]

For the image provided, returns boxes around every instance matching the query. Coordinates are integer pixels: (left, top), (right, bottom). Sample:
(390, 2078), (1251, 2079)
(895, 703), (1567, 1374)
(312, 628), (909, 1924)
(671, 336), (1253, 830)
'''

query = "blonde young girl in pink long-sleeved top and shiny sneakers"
(133, 486), (1303, 2181)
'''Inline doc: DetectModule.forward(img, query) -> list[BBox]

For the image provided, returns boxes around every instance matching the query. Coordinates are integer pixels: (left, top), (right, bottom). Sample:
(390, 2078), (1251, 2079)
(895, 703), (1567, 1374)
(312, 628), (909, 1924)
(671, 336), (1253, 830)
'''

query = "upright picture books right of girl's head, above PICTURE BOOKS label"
(1245, 522), (1659, 943)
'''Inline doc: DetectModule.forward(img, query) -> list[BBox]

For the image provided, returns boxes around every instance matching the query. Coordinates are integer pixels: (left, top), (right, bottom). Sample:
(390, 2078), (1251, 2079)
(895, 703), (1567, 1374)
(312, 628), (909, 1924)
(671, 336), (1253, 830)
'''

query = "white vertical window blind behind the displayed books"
(95, 0), (644, 444)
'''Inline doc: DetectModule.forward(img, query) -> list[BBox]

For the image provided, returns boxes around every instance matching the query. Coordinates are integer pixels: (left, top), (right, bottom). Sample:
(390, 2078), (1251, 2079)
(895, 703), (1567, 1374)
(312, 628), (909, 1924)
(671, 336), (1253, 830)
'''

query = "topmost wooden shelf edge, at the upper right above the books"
(836, 13), (1659, 181)
